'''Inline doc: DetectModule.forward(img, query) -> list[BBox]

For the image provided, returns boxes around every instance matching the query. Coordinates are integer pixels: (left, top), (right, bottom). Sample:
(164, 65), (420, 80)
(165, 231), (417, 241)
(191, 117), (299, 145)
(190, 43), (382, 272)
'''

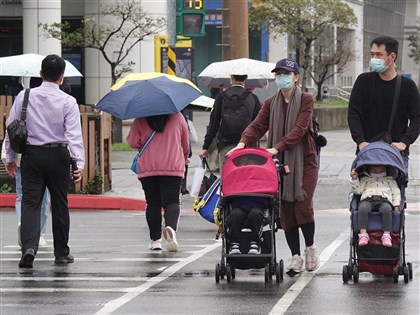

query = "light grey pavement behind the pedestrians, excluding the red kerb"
(106, 111), (420, 209)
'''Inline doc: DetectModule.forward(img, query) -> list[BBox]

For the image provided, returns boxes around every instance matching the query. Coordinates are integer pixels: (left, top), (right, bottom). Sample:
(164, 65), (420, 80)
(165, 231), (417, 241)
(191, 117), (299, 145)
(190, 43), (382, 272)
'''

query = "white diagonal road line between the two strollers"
(269, 229), (350, 315)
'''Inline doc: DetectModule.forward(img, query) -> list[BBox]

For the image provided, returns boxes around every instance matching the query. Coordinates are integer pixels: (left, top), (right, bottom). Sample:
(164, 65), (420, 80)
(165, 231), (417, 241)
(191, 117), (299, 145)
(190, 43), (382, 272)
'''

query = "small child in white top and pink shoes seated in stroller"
(350, 165), (401, 247)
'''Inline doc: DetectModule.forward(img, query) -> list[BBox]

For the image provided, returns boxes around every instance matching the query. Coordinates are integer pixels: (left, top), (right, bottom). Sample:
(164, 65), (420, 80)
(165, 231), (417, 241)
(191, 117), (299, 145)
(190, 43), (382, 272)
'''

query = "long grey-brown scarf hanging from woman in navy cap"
(267, 86), (306, 202)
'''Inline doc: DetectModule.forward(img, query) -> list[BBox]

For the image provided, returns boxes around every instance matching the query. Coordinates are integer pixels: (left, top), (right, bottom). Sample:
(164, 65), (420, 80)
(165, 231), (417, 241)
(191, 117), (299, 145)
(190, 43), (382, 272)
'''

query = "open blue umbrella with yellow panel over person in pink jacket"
(95, 72), (202, 119)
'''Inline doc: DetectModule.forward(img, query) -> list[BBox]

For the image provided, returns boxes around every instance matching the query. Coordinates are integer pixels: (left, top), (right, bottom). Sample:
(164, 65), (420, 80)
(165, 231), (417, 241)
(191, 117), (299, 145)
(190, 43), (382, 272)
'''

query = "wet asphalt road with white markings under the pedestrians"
(0, 110), (420, 315)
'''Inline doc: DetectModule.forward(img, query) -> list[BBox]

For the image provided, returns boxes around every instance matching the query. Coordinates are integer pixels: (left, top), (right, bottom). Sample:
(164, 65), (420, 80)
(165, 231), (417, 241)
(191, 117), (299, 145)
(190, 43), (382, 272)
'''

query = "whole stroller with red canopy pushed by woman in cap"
(215, 148), (283, 283)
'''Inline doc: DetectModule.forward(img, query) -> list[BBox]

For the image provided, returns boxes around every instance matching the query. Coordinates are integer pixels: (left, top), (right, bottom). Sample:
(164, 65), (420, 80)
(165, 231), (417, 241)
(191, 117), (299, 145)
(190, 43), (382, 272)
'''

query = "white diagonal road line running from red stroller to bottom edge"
(96, 242), (221, 315)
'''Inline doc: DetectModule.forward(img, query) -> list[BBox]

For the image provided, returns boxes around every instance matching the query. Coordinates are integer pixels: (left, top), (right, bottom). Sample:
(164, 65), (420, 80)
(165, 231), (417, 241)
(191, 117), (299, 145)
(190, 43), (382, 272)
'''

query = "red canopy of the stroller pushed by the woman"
(222, 148), (279, 197)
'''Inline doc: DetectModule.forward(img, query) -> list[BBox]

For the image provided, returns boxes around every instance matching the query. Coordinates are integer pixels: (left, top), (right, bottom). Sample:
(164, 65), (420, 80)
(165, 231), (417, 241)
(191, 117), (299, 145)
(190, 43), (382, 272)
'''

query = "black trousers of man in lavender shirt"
(20, 146), (70, 257)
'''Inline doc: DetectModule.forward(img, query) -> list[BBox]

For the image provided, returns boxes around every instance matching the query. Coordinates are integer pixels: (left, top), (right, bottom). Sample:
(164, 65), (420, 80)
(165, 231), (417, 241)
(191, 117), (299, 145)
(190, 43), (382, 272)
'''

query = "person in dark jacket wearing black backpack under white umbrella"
(199, 74), (261, 166)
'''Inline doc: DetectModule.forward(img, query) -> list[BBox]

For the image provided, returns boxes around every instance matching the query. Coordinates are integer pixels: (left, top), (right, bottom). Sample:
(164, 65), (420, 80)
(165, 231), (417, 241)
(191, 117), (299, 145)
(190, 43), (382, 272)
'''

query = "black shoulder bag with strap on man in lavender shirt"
(7, 89), (30, 153)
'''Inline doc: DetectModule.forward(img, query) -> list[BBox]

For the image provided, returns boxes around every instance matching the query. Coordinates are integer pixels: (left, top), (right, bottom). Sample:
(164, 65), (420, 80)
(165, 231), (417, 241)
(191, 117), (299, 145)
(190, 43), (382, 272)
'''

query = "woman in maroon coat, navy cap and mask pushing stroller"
(229, 59), (319, 276)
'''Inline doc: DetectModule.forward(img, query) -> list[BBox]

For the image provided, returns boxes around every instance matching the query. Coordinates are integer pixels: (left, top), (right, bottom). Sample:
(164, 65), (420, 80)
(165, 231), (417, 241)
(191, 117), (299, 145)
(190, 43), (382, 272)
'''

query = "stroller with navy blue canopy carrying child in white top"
(342, 141), (413, 283)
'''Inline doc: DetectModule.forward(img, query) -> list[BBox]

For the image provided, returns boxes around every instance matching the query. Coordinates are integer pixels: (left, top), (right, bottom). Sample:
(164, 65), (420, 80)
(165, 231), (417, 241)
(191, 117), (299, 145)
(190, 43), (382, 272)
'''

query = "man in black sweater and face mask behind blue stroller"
(347, 36), (420, 160)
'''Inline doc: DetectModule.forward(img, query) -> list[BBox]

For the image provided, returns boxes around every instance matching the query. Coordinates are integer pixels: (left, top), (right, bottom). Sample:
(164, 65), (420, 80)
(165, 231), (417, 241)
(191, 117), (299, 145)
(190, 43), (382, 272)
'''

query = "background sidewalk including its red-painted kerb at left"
(0, 112), (420, 210)
